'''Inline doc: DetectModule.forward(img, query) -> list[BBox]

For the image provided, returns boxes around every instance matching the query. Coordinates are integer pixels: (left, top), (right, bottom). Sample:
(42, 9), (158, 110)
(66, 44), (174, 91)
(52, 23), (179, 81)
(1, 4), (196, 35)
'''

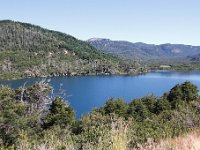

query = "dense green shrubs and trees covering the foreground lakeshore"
(0, 82), (200, 150)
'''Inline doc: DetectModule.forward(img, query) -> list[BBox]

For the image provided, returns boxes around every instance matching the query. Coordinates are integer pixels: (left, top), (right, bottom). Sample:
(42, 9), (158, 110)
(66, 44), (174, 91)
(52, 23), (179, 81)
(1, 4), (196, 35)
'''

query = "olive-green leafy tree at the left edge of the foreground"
(0, 87), (39, 147)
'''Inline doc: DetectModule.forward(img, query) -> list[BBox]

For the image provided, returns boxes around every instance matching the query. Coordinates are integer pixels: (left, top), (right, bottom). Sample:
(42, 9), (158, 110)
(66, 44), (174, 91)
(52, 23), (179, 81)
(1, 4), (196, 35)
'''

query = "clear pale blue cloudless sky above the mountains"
(0, 0), (200, 45)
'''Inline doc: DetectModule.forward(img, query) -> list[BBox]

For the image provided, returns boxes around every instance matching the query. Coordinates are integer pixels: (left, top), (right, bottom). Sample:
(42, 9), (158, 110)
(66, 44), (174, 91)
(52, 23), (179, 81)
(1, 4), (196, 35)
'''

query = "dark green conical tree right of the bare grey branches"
(44, 97), (75, 128)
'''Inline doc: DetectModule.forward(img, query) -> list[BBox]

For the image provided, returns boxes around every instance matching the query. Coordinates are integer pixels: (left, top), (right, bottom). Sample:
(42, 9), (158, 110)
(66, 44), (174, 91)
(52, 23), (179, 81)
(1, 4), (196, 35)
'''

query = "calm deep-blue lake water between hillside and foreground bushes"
(0, 71), (200, 118)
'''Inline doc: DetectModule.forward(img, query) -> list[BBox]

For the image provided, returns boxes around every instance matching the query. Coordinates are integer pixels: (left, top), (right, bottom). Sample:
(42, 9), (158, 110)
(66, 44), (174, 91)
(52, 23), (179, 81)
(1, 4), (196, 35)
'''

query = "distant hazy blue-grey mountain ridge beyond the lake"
(87, 38), (200, 60)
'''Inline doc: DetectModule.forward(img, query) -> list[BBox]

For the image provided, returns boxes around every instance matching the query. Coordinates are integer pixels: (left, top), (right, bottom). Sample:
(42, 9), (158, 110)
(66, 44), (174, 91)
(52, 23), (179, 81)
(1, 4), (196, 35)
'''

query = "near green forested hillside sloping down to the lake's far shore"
(0, 20), (145, 79)
